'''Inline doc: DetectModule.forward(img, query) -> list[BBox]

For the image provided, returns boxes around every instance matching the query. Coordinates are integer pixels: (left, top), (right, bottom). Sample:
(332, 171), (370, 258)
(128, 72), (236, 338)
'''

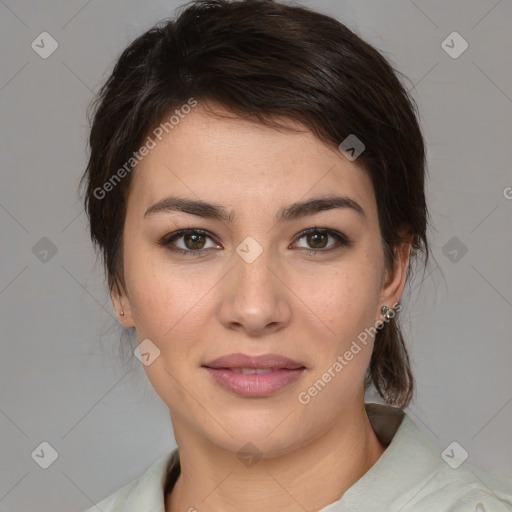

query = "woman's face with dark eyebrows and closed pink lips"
(112, 105), (408, 456)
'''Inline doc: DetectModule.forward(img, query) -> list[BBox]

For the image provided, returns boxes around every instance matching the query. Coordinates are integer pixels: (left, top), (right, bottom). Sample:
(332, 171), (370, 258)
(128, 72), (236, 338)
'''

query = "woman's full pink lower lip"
(205, 367), (305, 397)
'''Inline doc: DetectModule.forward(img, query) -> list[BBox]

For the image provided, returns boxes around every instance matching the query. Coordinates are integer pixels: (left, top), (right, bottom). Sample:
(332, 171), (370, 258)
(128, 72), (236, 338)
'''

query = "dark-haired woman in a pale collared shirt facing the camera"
(83, 0), (512, 512)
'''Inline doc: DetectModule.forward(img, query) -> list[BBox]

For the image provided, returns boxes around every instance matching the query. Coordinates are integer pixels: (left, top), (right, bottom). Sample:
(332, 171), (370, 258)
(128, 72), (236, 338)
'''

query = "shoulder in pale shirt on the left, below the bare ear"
(84, 449), (178, 512)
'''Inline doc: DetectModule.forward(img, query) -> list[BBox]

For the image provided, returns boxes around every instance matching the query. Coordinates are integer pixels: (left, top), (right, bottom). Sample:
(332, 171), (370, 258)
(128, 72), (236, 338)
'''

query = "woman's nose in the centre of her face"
(219, 250), (291, 336)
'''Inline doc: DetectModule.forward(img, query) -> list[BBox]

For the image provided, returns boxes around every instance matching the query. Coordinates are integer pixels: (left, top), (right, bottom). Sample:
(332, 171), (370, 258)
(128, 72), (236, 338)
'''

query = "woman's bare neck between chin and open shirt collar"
(165, 403), (385, 512)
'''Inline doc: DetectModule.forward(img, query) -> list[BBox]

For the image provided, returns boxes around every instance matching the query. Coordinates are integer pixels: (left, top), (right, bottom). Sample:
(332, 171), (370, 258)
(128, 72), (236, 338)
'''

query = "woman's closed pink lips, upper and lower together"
(203, 354), (306, 398)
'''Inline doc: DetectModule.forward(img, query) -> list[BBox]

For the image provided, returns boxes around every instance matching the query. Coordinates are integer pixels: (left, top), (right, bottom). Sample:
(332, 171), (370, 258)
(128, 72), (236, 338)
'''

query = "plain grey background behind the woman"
(0, 0), (512, 512)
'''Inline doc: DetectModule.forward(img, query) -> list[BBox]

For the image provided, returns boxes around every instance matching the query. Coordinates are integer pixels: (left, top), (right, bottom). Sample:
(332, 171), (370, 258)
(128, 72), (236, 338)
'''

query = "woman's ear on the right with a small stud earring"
(375, 228), (414, 323)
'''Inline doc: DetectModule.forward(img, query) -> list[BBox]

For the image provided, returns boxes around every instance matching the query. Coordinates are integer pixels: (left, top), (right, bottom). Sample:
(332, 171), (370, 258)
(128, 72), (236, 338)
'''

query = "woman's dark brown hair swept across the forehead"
(80, 0), (429, 407)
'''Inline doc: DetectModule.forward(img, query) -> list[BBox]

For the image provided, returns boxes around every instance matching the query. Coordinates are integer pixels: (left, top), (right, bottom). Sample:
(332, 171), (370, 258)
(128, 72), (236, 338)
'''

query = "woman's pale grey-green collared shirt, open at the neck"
(85, 403), (512, 512)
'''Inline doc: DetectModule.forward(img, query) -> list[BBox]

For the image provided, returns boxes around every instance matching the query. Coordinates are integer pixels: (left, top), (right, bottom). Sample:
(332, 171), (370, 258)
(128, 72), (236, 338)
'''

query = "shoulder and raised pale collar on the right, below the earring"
(358, 404), (512, 512)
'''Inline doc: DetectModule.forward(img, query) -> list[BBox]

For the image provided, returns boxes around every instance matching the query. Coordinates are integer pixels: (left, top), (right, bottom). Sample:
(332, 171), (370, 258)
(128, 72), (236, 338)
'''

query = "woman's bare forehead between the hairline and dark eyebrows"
(129, 105), (374, 216)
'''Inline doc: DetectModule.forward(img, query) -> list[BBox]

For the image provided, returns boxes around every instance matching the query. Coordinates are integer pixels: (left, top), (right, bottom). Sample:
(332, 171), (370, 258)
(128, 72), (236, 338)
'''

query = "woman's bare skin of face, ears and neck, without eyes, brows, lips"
(111, 104), (410, 512)
